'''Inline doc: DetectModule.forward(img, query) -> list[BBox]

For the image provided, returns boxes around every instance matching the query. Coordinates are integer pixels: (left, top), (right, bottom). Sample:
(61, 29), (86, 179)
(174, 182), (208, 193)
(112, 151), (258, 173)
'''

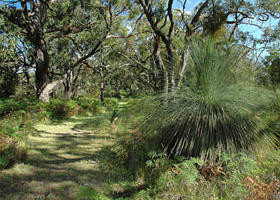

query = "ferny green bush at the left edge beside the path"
(0, 98), (38, 169)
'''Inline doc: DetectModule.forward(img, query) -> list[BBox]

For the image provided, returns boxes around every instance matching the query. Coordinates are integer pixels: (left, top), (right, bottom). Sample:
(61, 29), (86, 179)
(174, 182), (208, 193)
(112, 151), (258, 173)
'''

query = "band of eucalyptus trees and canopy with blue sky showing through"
(0, 0), (280, 100)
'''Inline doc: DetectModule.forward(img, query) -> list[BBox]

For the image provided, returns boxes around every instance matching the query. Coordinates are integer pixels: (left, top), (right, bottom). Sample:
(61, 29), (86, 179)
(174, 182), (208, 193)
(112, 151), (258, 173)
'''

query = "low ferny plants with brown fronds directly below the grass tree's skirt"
(135, 152), (279, 199)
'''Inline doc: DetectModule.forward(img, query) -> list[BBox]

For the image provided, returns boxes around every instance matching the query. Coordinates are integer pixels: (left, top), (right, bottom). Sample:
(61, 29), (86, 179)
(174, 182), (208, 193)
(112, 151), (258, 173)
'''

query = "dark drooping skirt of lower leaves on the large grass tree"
(160, 103), (257, 158)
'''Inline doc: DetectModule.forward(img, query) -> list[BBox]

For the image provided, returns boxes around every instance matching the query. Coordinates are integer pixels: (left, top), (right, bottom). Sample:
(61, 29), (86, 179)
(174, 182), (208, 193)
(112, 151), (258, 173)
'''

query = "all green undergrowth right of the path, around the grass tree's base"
(84, 96), (280, 200)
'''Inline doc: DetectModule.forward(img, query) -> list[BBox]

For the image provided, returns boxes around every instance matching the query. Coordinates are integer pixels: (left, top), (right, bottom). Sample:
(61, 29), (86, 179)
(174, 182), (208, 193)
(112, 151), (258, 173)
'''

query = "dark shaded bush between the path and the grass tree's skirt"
(98, 130), (149, 185)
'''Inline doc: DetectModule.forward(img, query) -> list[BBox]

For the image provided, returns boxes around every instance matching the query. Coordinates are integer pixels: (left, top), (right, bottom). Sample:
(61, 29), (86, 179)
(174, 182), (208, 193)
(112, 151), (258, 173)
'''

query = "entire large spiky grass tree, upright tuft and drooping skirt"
(142, 41), (276, 158)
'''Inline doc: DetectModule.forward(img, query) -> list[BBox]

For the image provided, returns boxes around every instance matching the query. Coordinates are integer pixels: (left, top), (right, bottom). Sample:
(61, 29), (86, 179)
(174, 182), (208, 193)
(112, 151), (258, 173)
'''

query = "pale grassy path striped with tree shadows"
(0, 115), (113, 200)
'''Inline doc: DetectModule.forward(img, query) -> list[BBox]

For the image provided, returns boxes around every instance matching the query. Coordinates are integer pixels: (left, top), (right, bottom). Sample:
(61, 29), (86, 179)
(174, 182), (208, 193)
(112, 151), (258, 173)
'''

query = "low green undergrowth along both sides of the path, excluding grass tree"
(0, 97), (280, 200)
